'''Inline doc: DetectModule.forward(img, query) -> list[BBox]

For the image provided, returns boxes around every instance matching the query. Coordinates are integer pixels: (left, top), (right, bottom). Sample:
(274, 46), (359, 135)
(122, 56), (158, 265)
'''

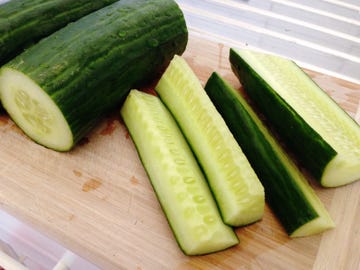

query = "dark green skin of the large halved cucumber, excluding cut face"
(5, 0), (188, 148)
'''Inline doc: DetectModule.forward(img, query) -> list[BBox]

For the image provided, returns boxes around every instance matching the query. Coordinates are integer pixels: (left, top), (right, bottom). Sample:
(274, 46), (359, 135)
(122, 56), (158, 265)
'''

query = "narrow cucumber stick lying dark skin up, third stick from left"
(205, 73), (334, 237)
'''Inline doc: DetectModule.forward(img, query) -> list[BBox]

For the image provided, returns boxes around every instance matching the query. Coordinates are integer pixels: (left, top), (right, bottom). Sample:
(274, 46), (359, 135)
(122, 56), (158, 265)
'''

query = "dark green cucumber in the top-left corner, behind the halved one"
(0, 0), (117, 66)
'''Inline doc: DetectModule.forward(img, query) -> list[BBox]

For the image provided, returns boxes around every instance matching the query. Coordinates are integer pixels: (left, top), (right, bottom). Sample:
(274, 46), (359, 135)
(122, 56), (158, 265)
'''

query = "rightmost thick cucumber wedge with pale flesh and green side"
(230, 49), (360, 187)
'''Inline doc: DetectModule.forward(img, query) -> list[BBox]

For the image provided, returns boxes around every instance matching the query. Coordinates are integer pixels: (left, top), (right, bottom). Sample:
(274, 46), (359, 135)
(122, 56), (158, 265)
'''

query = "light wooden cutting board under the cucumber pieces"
(0, 36), (360, 270)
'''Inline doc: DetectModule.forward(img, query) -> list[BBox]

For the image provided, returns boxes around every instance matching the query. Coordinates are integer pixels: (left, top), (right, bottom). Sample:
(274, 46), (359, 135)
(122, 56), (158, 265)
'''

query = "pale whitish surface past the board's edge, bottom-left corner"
(0, 210), (99, 270)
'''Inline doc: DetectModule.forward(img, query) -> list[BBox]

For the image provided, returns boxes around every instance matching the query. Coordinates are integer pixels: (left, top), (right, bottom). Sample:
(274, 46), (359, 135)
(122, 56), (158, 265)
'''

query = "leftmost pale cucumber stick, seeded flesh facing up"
(120, 90), (238, 255)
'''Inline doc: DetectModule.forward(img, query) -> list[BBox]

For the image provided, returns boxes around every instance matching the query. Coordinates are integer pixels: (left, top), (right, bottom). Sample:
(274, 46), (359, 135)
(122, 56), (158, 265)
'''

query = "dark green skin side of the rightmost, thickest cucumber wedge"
(229, 49), (337, 182)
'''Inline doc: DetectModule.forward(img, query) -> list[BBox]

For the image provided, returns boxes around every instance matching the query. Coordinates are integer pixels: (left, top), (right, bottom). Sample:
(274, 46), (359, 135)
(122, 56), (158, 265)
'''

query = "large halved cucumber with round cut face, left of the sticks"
(0, 0), (188, 151)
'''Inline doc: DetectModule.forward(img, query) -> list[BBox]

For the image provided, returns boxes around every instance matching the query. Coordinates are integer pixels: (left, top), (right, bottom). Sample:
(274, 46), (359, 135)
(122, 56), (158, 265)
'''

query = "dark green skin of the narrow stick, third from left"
(205, 73), (318, 235)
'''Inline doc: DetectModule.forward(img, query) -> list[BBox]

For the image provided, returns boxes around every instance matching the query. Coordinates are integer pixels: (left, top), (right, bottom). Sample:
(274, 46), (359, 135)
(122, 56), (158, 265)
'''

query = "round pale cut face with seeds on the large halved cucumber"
(0, 67), (73, 151)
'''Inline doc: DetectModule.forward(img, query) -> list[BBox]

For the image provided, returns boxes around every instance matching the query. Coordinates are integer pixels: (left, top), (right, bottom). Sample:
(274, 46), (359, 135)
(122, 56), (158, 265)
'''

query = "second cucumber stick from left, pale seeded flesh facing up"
(155, 55), (265, 226)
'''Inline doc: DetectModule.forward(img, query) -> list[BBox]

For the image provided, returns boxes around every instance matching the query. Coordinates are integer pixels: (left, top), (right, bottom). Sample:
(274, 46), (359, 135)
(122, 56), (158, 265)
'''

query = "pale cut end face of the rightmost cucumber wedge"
(321, 155), (360, 187)
